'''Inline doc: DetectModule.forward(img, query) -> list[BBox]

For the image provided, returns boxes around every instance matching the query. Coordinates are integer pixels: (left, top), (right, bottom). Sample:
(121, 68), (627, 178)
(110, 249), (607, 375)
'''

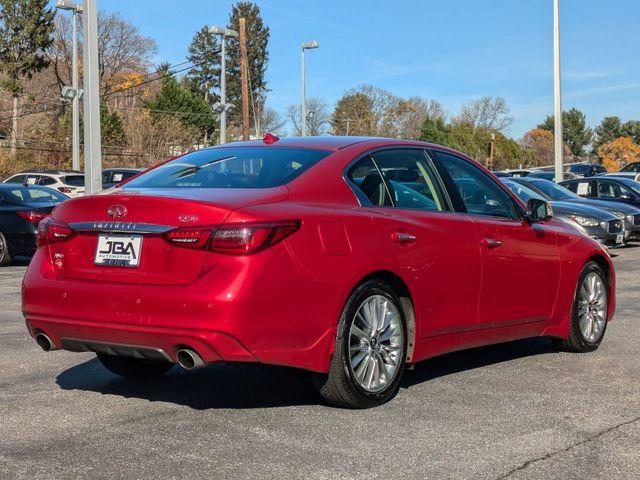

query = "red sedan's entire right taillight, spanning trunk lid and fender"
(164, 220), (300, 255)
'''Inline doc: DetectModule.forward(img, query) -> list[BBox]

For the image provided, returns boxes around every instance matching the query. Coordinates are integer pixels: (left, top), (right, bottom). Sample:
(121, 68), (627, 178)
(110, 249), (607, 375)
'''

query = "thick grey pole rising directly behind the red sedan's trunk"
(82, 0), (102, 195)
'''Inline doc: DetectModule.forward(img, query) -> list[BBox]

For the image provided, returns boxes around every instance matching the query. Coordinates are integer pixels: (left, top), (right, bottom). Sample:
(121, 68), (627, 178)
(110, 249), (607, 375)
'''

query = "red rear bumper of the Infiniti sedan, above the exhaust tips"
(22, 248), (343, 372)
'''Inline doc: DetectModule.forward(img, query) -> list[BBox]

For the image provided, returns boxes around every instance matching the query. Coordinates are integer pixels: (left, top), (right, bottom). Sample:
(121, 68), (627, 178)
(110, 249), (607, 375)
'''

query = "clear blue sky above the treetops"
(98, 0), (640, 137)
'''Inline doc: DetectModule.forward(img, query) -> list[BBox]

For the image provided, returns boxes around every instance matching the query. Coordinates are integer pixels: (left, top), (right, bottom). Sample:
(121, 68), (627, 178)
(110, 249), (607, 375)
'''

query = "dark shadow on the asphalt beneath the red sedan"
(56, 338), (556, 410)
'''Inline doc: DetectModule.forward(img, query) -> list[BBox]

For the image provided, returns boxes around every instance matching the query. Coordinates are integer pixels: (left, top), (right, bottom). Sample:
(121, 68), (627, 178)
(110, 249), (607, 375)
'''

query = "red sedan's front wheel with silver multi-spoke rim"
(554, 262), (609, 353)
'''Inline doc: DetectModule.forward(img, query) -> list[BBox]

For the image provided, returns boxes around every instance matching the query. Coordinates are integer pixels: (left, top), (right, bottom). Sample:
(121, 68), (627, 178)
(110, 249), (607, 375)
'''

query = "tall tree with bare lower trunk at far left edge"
(0, 0), (55, 154)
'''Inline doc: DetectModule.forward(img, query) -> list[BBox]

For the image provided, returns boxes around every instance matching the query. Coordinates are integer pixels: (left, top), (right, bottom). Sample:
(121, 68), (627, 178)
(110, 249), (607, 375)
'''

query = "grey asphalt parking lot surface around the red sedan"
(0, 247), (640, 479)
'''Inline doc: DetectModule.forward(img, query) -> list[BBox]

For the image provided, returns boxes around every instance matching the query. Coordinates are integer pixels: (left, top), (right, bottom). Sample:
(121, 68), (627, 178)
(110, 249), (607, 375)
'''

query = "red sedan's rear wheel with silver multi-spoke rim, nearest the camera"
(314, 280), (407, 408)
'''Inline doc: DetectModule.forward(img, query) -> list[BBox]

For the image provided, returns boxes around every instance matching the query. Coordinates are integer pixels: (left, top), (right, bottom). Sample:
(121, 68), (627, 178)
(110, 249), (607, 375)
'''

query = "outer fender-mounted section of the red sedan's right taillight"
(209, 220), (300, 255)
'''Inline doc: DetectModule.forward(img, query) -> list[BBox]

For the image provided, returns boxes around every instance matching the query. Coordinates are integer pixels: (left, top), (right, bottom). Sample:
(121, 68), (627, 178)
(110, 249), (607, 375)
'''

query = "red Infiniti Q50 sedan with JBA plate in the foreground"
(23, 136), (615, 408)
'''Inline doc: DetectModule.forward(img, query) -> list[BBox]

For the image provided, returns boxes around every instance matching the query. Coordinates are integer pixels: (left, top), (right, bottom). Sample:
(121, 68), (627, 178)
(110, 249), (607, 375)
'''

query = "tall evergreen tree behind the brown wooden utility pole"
(227, 2), (269, 125)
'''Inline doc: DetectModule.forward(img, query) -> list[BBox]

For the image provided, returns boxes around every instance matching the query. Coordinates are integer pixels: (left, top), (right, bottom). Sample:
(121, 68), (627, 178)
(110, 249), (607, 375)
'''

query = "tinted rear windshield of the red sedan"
(123, 147), (332, 188)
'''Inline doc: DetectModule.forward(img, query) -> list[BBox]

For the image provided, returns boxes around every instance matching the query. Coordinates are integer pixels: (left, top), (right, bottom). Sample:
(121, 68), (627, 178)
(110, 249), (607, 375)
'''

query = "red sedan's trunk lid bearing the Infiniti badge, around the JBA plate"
(49, 186), (288, 285)
